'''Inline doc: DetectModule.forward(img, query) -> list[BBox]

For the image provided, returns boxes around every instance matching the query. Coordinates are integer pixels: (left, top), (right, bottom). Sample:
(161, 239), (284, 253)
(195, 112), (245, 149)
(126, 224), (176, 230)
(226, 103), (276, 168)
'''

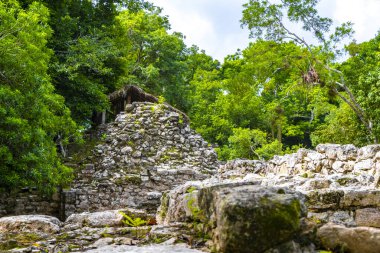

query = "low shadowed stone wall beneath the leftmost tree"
(0, 188), (61, 217)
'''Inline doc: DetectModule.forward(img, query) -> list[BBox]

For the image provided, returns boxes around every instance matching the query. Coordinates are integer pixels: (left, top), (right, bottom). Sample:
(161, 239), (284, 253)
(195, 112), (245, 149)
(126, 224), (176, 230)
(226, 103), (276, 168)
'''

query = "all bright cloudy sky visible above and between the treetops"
(151, 0), (380, 61)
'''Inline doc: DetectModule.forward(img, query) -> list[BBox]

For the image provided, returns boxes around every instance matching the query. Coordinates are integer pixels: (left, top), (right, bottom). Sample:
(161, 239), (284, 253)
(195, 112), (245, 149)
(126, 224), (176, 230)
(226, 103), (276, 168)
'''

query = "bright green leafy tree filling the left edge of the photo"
(0, 0), (76, 191)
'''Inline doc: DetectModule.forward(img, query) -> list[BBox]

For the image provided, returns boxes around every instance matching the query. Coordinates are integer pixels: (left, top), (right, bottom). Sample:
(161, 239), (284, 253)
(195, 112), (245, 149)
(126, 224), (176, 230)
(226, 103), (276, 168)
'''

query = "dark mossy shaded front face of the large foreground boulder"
(218, 194), (302, 252)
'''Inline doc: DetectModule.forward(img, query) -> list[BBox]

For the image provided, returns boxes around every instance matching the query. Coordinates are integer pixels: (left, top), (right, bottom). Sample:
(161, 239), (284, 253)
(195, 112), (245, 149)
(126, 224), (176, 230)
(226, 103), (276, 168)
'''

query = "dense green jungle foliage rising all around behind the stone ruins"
(0, 0), (380, 191)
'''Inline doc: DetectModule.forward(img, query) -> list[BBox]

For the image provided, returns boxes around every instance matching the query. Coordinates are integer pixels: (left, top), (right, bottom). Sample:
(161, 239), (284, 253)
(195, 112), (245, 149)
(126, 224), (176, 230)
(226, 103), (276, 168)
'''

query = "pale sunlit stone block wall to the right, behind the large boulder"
(217, 144), (380, 228)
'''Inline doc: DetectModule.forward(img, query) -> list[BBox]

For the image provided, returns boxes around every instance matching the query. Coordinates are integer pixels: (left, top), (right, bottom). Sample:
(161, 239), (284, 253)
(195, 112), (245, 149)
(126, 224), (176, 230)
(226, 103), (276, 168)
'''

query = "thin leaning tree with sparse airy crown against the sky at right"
(241, 0), (377, 143)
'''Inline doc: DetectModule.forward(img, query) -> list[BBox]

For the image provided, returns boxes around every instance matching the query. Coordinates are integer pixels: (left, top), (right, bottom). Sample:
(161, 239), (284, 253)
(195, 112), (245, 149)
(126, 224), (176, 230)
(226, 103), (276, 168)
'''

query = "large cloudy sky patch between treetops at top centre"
(152, 0), (249, 61)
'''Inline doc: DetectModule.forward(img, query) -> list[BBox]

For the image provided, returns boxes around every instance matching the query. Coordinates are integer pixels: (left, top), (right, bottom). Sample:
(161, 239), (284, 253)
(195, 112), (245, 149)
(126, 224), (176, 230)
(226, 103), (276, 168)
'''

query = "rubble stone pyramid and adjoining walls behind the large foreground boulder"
(0, 98), (380, 233)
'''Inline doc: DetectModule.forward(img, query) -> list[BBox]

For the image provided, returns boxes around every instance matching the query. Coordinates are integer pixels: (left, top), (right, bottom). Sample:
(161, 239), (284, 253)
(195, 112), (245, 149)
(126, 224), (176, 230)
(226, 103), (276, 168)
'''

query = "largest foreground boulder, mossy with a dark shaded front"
(158, 183), (306, 253)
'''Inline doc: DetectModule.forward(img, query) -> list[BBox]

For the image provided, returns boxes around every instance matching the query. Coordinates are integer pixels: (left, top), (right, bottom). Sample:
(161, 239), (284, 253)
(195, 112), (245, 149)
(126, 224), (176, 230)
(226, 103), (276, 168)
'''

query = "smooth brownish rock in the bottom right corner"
(317, 223), (380, 253)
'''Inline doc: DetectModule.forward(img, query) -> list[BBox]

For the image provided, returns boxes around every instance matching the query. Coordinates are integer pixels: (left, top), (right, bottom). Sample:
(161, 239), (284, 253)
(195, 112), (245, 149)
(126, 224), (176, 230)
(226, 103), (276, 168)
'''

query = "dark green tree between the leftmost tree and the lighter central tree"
(45, 0), (122, 125)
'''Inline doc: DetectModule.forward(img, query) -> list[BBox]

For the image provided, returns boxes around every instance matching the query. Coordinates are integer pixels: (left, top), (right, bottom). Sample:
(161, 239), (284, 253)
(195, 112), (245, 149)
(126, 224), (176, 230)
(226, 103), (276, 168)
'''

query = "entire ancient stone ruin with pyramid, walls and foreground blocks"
(0, 89), (380, 253)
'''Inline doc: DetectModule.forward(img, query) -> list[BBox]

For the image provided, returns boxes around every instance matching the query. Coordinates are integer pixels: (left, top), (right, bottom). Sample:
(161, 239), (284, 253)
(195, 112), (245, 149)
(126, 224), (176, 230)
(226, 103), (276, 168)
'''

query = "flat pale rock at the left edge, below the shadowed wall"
(0, 215), (61, 234)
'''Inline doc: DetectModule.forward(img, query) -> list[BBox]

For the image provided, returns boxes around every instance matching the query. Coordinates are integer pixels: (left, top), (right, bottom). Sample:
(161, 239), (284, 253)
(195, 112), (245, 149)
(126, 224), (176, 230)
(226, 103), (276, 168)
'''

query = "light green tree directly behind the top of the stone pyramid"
(116, 9), (188, 111)
